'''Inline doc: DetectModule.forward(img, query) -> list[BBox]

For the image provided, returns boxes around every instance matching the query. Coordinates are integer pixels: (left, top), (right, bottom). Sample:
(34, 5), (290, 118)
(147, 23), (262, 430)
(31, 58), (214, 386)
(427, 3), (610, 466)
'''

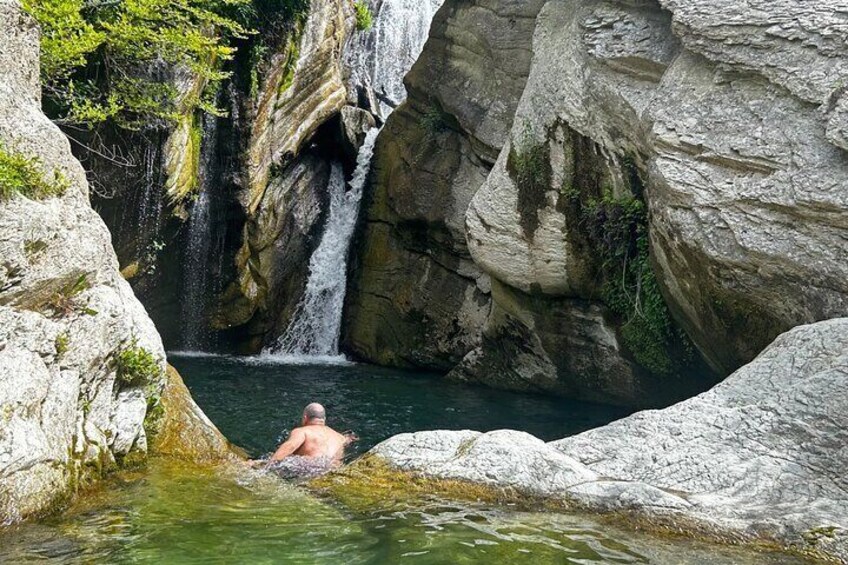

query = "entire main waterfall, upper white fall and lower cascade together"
(265, 0), (444, 363)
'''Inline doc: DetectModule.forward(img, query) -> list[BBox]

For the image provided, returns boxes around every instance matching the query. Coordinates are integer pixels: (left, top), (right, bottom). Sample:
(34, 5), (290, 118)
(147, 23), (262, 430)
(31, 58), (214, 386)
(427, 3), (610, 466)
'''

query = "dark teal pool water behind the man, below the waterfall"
(171, 356), (627, 456)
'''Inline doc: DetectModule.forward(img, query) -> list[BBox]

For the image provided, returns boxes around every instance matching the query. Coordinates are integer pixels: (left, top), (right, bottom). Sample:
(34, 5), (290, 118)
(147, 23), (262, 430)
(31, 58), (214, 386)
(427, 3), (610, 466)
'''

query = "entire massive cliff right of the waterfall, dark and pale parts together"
(348, 0), (848, 405)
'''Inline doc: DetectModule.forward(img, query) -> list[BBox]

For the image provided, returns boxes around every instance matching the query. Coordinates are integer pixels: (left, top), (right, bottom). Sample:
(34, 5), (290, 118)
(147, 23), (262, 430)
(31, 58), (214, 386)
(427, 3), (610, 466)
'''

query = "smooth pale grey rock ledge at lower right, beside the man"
(356, 318), (848, 563)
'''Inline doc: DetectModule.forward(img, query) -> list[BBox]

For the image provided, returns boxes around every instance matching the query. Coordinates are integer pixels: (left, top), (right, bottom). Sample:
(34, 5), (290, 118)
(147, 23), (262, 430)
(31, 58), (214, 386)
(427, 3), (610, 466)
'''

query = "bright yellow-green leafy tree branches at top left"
(23, 0), (250, 130)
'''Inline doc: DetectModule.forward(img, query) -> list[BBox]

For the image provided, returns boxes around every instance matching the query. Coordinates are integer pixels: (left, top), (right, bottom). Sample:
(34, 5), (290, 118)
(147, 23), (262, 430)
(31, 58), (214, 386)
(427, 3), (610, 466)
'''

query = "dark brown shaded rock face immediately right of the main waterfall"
(343, 0), (542, 370)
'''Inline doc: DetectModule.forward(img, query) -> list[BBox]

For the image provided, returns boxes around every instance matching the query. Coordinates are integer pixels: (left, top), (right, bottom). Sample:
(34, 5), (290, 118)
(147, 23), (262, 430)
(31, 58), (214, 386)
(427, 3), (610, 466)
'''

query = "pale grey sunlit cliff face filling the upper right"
(459, 1), (848, 402)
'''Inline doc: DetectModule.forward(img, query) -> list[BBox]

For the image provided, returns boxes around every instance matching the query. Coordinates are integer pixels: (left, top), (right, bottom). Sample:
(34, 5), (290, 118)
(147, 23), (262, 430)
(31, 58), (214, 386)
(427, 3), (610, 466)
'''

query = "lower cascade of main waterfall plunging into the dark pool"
(268, 128), (379, 361)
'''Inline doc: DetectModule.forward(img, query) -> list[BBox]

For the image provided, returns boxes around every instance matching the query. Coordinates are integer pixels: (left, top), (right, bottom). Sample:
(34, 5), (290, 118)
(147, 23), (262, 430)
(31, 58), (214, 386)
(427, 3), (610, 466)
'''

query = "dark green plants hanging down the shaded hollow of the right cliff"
(582, 191), (693, 375)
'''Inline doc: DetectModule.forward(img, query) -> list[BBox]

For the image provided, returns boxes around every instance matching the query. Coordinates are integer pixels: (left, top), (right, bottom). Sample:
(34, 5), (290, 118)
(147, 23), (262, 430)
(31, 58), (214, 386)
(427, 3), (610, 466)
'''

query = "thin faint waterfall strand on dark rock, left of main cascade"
(181, 115), (218, 351)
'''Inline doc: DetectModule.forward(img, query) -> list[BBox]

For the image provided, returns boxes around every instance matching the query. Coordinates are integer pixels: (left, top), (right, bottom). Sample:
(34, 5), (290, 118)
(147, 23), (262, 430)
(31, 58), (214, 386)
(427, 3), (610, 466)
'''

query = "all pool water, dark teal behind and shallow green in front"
(0, 357), (800, 565)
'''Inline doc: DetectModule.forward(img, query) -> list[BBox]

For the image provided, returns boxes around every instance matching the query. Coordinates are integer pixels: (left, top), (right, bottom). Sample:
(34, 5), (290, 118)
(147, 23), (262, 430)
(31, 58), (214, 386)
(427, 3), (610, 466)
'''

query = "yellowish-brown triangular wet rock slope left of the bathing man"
(150, 365), (246, 462)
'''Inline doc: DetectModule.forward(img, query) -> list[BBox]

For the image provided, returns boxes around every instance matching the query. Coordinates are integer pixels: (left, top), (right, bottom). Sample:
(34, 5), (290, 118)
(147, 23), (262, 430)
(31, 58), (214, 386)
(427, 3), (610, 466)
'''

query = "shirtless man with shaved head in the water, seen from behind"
(270, 402), (356, 463)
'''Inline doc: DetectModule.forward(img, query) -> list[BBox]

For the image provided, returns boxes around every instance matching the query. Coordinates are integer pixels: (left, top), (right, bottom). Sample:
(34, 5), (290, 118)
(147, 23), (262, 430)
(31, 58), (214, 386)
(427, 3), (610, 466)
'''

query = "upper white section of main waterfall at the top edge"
(345, 0), (444, 120)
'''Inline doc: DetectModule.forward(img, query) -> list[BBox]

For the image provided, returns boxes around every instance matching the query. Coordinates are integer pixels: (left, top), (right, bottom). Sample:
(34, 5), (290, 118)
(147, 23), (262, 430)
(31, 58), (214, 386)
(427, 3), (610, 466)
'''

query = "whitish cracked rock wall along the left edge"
(0, 0), (238, 524)
